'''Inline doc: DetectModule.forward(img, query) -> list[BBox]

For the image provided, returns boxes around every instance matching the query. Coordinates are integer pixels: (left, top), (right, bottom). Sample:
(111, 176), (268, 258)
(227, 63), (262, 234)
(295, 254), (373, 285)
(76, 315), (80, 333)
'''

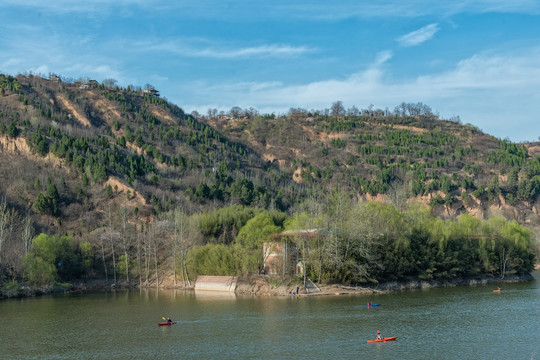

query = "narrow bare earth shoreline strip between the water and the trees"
(0, 269), (538, 299)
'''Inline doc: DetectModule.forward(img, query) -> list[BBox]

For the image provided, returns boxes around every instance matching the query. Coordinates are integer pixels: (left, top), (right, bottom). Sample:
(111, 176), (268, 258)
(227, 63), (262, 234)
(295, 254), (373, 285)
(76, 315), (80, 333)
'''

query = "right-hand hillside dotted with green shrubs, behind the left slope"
(203, 108), (540, 227)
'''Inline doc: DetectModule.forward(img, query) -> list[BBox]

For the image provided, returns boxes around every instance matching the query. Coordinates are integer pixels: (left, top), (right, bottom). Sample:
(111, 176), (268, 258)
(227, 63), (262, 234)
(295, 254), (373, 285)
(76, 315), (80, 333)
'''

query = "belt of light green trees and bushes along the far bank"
(1, 191), (535, 296)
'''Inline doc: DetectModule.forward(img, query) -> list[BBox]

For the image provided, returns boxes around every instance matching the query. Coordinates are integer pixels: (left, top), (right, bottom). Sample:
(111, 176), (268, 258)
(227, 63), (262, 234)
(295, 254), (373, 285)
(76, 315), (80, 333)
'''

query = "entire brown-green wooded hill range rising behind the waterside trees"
(0, 75), (540, 239)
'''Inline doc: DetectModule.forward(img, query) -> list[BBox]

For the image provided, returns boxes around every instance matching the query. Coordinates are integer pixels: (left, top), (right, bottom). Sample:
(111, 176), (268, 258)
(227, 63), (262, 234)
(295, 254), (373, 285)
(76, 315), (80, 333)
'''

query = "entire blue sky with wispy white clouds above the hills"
(0, 0), (540, 142)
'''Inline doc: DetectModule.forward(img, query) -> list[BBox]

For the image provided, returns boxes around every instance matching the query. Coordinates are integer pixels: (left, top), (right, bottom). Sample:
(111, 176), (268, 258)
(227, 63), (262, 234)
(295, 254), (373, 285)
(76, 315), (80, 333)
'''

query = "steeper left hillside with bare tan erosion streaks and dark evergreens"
(0, 76), (304, 232)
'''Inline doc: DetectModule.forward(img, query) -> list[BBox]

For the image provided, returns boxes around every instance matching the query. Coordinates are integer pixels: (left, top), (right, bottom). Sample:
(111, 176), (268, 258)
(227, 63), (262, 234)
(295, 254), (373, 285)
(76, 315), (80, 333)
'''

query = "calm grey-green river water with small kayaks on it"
(0, 274), (540, 360)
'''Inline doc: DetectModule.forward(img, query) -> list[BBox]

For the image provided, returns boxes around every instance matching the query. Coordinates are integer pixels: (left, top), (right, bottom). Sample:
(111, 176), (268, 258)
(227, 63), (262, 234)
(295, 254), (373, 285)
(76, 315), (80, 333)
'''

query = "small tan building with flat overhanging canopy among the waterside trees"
(263, 229), (319, 275)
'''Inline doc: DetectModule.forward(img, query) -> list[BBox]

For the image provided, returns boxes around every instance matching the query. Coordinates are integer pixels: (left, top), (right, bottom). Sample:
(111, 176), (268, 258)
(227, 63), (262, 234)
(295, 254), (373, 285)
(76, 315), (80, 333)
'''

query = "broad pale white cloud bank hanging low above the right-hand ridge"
(182, 48), (540, 141)
